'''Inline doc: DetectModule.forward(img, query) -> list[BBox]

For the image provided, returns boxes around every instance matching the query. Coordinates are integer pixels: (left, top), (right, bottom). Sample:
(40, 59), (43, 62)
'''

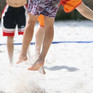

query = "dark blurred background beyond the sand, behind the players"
(0, 0), (93, 20)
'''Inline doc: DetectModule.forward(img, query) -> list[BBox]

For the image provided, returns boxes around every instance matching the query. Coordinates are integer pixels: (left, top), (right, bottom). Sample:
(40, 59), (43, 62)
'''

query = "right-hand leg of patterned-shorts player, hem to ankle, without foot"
(40, 17), (54, 60)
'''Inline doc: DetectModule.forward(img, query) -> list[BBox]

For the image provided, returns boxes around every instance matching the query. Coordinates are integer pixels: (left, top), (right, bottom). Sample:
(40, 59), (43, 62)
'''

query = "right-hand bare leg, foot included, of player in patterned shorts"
(28, 16), (54, 71)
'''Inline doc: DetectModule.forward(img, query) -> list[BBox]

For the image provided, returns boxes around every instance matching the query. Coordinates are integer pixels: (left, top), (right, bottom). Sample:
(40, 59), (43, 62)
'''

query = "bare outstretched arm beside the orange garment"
(76, 2), (93, 20)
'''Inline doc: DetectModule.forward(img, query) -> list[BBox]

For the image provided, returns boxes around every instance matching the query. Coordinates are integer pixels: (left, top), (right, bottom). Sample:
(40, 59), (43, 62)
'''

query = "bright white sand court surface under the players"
(0, 21), (93, 93)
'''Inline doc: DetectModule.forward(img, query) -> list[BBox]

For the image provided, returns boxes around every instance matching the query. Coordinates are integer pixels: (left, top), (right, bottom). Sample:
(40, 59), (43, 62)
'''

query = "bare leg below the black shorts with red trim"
(7, 36), (14, 64)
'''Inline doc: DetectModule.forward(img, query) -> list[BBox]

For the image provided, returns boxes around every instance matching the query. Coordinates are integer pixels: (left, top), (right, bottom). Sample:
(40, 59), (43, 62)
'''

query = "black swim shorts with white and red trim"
(1, 5), (26, 36)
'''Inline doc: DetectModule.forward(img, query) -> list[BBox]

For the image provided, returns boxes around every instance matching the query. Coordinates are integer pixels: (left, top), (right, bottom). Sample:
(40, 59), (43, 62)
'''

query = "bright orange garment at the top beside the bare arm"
(59, 0), (82, 13)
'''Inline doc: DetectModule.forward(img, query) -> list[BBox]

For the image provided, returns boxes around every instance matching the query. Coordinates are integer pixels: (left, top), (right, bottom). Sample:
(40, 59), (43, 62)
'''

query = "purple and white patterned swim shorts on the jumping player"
(28, 0), (60, 18)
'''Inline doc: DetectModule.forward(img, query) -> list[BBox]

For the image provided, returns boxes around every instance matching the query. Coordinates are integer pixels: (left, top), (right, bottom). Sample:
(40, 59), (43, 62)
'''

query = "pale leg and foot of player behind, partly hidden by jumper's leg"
(35, 26), (46, 74)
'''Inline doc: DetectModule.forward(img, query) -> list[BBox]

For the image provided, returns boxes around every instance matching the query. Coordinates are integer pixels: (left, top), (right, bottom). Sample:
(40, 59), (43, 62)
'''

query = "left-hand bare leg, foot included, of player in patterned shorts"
(17, 13), (38, 64)
